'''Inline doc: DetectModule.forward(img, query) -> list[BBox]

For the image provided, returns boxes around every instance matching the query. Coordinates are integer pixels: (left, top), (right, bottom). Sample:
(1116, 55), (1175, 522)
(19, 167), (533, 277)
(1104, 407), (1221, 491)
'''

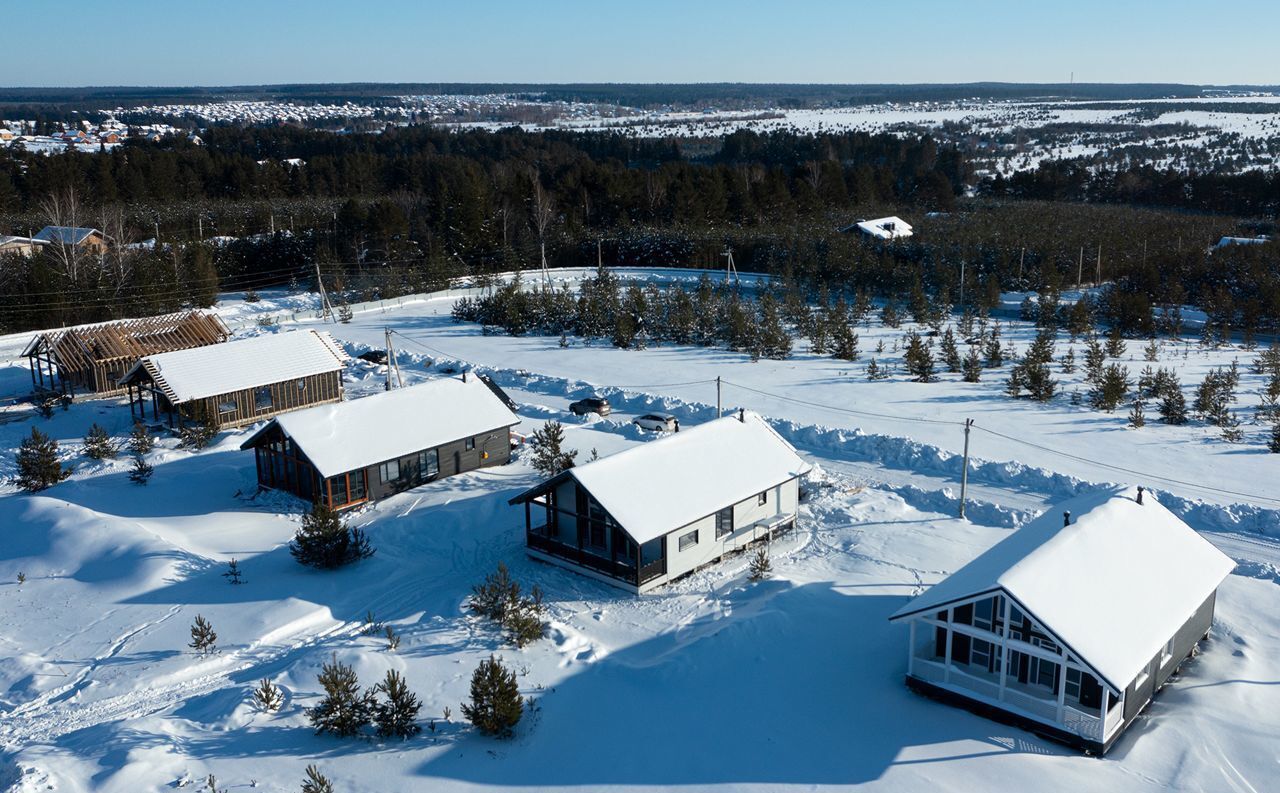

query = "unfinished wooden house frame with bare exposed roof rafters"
(23, 311), (230, 397)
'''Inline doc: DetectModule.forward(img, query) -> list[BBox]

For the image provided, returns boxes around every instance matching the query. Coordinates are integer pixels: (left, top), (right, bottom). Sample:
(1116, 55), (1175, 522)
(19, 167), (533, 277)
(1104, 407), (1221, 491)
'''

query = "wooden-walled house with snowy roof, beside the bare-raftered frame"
(120, 330), (349, 428)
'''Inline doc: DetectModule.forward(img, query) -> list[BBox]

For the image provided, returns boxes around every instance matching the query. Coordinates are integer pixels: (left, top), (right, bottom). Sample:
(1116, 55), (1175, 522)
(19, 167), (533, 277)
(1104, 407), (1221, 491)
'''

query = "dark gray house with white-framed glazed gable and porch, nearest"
(890, 487), (1235, 755)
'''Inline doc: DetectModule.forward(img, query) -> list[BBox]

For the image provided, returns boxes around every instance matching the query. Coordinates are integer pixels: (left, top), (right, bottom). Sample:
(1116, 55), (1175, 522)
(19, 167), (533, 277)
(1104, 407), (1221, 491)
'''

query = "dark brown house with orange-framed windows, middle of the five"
(241, 373), (520, 509)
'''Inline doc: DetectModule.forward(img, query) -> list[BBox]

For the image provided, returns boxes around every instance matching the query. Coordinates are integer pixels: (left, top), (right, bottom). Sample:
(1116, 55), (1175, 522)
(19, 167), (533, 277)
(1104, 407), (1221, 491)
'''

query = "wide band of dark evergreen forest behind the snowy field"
(0, 127), (1280, 333)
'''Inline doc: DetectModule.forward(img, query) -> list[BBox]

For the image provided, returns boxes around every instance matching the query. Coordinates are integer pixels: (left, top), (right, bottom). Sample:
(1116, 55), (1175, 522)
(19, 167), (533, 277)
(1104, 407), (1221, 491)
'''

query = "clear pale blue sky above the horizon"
(0, 0), (1280, 86)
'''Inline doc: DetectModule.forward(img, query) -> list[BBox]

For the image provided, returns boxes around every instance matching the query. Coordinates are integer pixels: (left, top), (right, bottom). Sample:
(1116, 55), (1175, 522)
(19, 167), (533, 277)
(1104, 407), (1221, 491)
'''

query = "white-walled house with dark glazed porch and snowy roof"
(511, 412), (809, 592)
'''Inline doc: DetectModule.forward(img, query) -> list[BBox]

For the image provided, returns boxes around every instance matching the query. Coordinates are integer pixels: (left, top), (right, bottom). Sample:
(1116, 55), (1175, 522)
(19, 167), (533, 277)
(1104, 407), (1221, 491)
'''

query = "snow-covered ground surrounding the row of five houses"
(0, 281), (1280, 793)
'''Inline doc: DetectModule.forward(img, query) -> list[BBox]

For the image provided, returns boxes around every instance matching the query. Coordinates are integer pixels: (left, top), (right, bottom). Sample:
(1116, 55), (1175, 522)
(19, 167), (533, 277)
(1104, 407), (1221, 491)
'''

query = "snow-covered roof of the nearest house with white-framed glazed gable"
(891, 487), (1235, 689)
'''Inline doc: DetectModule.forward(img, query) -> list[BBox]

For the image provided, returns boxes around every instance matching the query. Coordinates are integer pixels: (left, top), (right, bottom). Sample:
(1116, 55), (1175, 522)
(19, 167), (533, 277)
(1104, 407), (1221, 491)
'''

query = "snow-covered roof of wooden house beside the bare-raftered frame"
(120, 330), (349, 404)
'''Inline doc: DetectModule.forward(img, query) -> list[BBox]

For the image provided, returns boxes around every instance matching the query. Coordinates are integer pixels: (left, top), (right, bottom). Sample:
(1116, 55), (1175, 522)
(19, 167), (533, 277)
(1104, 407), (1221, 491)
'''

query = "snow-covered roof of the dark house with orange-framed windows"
(241, 376), (520, 478)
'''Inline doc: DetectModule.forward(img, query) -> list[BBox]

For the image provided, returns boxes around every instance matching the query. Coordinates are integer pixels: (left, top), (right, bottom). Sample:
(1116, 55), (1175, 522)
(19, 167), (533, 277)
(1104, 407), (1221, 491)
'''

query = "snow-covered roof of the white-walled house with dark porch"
(519, 413), (809, 544)
